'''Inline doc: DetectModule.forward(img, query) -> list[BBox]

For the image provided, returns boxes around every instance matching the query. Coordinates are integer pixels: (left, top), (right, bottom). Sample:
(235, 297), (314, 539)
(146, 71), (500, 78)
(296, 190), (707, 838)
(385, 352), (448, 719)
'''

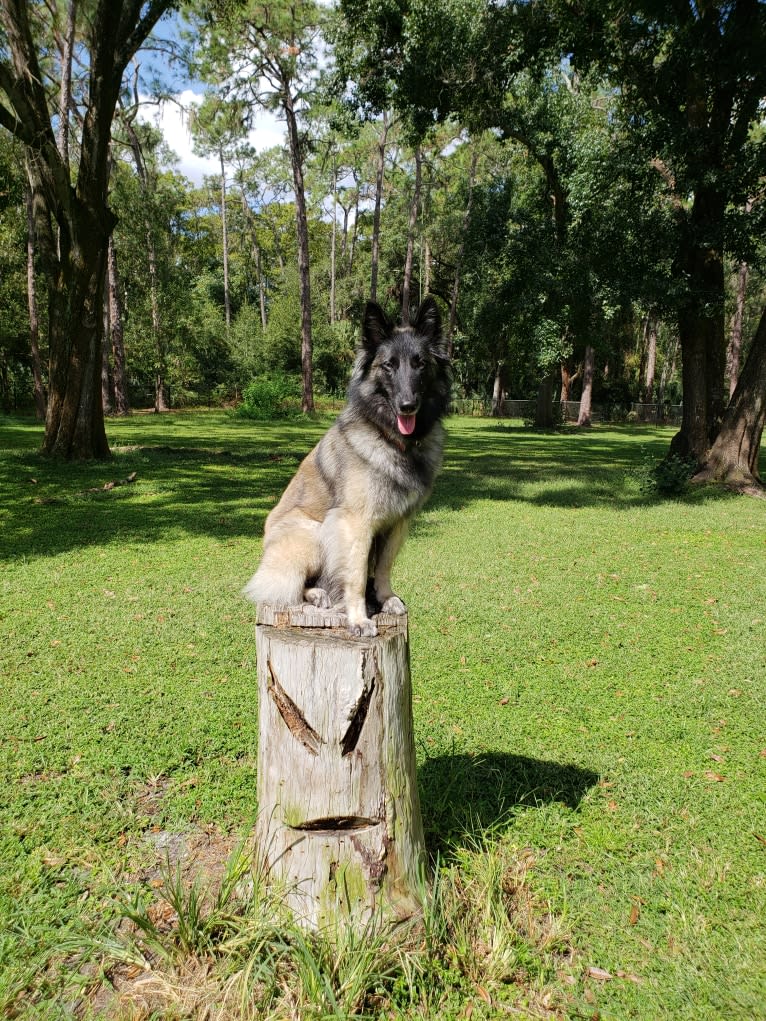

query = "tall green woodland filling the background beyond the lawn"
(0, 0), (766, 484)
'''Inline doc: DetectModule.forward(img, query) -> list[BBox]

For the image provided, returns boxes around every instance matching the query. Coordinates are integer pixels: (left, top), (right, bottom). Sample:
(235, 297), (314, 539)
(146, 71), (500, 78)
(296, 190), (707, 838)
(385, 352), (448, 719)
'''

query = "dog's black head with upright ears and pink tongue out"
(348, 298), (449, 443)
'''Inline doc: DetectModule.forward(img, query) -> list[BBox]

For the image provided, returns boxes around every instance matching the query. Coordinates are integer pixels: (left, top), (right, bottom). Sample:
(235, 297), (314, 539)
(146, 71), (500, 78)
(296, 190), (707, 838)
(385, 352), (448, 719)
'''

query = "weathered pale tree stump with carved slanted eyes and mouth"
(255, 604), (425, 928)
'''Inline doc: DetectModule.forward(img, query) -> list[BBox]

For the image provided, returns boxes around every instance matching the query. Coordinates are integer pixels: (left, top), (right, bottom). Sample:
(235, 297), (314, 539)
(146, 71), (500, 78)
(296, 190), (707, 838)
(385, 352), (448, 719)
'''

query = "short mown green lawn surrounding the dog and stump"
(0, 412), (766, 1021)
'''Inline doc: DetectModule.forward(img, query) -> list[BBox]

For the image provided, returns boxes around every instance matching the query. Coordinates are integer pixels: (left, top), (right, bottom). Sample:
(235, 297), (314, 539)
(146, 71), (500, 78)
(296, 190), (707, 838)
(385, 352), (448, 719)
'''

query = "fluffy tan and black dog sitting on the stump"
(244, 297), (450, 636)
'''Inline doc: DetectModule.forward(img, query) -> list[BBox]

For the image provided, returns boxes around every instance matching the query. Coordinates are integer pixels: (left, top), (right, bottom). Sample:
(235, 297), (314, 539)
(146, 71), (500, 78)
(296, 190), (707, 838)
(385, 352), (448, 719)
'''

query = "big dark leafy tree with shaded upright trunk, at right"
(559, 0), (766, 465)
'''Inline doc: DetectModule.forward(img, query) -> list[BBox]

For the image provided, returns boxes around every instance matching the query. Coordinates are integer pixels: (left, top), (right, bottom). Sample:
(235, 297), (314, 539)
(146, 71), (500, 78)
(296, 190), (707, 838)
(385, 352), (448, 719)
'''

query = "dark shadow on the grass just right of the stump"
(418, 751), (600, 856)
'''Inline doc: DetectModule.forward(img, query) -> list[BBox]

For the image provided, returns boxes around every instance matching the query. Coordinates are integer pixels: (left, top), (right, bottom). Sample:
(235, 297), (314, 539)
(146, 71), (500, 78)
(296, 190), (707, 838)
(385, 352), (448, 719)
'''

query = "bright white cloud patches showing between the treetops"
(139, 89), (285, 185)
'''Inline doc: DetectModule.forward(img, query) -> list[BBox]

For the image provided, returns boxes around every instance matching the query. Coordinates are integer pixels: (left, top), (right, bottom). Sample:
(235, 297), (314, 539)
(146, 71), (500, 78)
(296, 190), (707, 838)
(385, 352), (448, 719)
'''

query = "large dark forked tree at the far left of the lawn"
(0, 0), (174, 458)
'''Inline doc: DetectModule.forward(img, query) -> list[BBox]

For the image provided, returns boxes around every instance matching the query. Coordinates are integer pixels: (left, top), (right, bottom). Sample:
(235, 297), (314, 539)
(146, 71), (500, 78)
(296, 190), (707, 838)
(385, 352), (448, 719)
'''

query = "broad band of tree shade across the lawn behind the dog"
(0, 415), (743, 558)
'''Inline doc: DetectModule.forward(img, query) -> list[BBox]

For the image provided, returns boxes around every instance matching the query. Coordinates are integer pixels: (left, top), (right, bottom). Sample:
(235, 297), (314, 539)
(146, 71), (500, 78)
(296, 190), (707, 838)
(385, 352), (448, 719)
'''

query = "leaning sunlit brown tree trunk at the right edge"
(695, 307), (766, 491)
